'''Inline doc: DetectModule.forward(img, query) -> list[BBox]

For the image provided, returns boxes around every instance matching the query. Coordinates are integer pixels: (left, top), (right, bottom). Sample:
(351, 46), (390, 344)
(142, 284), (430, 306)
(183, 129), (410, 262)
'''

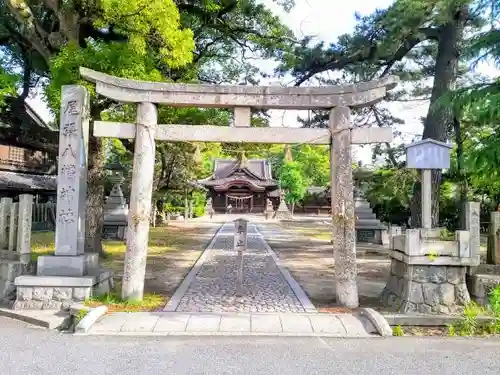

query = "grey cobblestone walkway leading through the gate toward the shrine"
(175, 223), (305, 313)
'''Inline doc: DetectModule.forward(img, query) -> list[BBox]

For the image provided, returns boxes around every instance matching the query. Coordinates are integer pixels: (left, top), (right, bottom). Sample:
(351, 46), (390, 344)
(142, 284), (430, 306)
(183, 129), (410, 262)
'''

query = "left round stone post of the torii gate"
(122, 103), (158, 300)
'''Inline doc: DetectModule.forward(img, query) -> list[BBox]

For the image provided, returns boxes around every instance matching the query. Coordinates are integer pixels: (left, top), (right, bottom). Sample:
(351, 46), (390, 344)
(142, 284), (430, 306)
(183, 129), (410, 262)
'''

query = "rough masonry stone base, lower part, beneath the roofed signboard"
(381, 258), (470, 314)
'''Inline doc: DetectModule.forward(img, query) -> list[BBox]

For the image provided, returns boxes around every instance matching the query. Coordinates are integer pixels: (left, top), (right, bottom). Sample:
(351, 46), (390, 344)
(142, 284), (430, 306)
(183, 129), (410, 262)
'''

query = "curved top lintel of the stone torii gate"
(80, 67), (399, 110)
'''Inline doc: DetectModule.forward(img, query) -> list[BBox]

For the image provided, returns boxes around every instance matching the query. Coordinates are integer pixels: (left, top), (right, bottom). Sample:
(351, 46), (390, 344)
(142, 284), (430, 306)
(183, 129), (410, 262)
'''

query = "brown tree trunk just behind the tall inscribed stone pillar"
(85, 108), (106, 254)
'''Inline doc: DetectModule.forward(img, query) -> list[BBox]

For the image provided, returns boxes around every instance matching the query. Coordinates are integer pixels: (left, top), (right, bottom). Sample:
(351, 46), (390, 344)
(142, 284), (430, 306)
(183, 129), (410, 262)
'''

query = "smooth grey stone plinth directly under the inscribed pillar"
(36, 253), (99, 277)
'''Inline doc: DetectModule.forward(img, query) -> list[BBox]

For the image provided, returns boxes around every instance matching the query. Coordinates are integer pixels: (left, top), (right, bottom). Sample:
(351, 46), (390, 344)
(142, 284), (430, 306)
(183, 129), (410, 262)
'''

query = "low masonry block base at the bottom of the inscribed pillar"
(13, 270), (113, 310)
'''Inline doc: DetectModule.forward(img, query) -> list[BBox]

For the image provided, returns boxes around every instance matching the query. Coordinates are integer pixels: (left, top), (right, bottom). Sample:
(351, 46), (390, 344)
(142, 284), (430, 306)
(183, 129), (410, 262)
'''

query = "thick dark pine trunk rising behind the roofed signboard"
(411, 6), (468, 228)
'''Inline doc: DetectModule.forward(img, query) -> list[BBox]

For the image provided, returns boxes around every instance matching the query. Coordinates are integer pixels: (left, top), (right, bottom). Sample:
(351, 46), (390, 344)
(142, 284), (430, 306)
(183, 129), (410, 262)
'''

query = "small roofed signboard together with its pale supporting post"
(406, 138), (452, 229)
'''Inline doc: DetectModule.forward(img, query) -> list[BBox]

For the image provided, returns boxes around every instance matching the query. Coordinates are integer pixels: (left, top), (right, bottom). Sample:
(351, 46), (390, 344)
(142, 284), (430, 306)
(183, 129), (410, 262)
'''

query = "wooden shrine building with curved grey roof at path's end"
(198, 158), (279, 213)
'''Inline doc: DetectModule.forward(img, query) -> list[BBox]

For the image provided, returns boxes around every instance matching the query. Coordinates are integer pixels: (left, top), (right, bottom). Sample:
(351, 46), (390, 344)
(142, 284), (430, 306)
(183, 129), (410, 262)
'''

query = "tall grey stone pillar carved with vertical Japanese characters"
(55, 85), (89, 256)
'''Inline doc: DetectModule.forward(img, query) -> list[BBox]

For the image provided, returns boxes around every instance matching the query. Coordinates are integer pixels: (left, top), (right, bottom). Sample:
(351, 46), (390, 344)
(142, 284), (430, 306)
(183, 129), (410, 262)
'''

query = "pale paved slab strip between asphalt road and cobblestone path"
(86, 312), (379, 337)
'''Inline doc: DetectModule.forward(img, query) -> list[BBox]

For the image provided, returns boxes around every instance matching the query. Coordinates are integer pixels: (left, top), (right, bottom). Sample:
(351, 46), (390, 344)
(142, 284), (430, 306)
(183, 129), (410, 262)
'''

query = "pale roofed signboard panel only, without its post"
(406, 139), (452, 169)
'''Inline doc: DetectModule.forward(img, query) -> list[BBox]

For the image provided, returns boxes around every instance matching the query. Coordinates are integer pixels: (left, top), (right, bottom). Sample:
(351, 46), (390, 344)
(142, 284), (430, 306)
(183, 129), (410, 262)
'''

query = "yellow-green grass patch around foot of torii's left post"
(85, 292), (167, 312)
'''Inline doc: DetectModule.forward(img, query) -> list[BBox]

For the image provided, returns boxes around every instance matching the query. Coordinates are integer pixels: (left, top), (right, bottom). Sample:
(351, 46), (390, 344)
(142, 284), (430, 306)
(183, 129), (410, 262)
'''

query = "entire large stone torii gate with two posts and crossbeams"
(79, 68), (398, 308)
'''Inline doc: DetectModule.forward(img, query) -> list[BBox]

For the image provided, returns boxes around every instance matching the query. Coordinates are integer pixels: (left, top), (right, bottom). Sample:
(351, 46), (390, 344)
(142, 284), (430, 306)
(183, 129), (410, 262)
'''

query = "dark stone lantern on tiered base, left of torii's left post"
(103, 163), (128, 240)
